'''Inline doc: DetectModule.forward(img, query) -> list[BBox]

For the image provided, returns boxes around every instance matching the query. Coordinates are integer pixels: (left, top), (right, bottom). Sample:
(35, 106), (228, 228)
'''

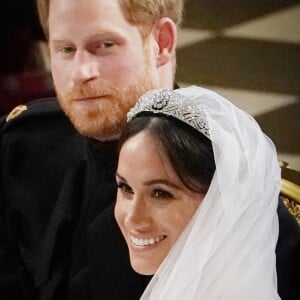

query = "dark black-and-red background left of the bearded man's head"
(0, 0), (54, 115)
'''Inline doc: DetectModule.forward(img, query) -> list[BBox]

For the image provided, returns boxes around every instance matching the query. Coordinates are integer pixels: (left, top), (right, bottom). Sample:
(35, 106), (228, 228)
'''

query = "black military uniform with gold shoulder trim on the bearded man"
(0, 99), (300, 300)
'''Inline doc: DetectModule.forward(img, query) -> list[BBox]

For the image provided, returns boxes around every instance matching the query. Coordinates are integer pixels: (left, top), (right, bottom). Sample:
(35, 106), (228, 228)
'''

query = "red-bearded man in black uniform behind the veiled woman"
(0, 0), (297, 299)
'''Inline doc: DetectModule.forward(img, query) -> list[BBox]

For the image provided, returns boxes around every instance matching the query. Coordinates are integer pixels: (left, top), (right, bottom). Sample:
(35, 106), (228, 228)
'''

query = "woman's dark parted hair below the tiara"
(119, 113), (216, 193)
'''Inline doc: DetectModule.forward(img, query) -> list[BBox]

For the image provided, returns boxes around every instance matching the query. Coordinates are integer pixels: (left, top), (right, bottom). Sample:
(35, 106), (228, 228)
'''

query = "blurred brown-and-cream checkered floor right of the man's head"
(177, 0), (300, 171)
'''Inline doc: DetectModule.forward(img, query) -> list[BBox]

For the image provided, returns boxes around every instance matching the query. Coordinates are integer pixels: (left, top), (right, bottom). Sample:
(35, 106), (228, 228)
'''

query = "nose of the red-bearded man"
(71, 50), (100, 84)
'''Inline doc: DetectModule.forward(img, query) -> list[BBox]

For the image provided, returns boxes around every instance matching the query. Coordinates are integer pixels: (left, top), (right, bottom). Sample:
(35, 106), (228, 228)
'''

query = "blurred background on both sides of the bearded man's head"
(0, 0), (300, 171)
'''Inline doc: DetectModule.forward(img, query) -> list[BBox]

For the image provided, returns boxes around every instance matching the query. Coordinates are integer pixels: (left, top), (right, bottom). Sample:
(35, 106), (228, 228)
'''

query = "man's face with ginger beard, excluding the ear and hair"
(49, 0), (157, 140)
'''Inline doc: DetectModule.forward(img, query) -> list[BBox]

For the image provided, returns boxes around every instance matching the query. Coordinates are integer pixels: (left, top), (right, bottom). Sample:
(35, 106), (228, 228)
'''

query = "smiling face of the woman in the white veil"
(115, 132), (204, 275)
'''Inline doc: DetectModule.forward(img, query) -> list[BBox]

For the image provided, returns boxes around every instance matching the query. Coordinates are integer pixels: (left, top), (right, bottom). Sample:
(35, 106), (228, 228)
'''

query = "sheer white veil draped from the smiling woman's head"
(141, 86), (280, 300)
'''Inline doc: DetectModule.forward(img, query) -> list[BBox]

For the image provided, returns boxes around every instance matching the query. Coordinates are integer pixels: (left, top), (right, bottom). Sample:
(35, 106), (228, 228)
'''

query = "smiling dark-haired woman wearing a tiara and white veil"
(115, 87), (280, 300)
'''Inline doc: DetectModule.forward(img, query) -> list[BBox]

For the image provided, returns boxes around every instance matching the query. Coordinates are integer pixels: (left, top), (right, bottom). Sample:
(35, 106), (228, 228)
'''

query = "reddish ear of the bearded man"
(155, 17), (177, 67)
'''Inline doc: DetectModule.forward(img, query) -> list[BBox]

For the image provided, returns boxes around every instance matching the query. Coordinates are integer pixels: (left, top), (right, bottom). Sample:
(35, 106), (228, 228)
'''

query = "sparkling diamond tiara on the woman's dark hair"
(127, 89), (210, 139)
